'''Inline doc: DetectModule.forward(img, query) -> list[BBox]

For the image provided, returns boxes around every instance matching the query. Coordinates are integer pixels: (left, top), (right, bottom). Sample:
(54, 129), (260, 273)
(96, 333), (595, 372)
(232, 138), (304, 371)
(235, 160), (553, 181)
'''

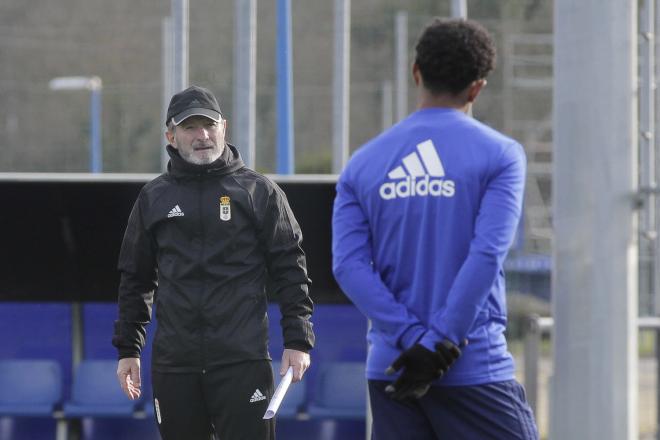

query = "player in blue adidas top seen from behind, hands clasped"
(332, 19), (538, 440)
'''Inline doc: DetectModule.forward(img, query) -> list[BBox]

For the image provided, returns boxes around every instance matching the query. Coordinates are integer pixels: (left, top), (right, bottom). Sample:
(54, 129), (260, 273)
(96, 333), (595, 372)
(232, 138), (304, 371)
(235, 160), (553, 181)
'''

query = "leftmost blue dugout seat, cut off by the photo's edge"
(0, 359), (62, 416)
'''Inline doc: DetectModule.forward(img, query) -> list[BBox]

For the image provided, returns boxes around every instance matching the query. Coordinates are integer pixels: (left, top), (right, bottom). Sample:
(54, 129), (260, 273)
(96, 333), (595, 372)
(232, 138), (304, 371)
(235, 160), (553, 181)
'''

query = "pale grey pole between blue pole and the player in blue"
(332, 0), (351, 174)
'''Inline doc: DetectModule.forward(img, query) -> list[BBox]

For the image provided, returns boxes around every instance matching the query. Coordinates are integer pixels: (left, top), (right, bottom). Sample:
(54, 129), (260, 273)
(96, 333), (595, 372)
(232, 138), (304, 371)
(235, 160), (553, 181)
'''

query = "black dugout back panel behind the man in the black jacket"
(0, 175), (347, 303)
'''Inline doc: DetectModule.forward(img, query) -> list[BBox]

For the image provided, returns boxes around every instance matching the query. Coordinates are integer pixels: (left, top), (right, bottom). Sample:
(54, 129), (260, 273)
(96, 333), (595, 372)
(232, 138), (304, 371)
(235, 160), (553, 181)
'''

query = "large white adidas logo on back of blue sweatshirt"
(379, 139), (456, 200)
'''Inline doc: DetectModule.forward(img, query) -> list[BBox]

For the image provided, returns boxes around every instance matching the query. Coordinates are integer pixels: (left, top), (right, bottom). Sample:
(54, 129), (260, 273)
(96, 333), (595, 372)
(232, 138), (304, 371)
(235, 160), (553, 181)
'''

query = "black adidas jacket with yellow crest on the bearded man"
(112, 145), (314, 372)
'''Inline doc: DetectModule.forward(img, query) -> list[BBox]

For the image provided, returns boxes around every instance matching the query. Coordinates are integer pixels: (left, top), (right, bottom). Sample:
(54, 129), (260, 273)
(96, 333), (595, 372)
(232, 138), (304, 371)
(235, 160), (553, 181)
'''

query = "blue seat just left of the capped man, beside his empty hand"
(64, 360), (139, 418)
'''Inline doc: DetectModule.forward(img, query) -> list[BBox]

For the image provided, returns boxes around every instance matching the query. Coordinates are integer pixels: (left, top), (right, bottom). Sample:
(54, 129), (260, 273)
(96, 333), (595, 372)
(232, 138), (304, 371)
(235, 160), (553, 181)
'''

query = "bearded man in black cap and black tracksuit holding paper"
(113, 86), (314, 440)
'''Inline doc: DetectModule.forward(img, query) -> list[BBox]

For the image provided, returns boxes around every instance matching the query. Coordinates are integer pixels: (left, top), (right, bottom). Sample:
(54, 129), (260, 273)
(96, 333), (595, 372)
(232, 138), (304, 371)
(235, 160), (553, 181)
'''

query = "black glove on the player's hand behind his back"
(385, 339), (461, 401)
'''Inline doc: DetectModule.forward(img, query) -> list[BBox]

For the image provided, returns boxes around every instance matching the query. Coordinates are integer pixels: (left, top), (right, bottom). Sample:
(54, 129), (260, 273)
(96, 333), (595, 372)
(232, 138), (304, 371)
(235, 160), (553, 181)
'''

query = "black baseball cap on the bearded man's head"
(165, 86), (222, 125)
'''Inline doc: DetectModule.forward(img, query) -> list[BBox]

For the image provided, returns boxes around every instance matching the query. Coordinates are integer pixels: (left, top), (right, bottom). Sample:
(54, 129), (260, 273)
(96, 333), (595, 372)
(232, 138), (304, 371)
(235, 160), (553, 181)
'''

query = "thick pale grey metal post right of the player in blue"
(551, 0), (639, 440)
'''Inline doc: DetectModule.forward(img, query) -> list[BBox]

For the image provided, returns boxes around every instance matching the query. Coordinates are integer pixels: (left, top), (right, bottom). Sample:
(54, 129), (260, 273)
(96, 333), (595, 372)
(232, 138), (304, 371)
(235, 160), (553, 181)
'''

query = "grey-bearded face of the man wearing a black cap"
(167, 116), (227, 165)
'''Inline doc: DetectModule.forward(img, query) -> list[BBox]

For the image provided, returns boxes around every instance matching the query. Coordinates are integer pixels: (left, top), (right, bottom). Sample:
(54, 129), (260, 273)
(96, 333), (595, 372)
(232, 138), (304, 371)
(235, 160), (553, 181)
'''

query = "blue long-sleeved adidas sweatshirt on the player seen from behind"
(332, 108), (526, 385)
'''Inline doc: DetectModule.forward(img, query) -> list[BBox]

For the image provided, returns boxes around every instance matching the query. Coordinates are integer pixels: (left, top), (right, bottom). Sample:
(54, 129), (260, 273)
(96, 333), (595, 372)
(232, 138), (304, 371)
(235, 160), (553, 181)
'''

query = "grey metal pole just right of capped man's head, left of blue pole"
(232, 0), (257, 168)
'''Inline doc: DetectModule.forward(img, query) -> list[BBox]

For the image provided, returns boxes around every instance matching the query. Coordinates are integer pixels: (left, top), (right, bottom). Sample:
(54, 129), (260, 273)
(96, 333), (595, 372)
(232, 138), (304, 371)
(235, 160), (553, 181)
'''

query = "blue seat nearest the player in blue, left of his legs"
(308, 362), (367, 420)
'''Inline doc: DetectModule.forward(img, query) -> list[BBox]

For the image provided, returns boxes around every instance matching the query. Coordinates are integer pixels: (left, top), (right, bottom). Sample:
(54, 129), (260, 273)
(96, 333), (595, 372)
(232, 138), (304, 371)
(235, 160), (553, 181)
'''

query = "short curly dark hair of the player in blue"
(415, 18), (495, 95)
